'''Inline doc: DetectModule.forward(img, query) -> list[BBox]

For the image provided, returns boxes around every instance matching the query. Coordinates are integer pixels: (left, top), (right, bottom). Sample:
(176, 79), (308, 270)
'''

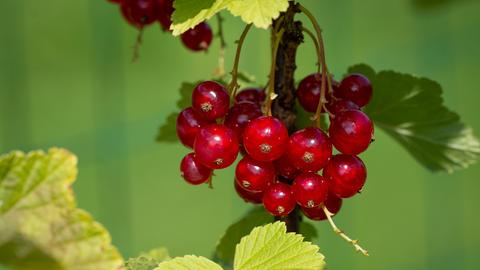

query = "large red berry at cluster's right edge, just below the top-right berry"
(329, 110), (373, 155)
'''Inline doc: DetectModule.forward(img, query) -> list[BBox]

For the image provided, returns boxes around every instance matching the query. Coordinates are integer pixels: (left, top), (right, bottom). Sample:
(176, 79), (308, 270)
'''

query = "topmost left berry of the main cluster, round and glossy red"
(192, 81), (230, 120)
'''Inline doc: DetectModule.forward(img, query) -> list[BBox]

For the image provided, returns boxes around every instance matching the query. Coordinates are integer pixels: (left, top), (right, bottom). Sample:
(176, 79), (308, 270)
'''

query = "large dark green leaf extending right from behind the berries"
(348, 64), (480, 172)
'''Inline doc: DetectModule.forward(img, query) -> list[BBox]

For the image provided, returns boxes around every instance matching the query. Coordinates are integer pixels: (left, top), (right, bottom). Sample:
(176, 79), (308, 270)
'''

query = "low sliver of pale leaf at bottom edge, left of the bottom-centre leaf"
(155, 255), (222, 270)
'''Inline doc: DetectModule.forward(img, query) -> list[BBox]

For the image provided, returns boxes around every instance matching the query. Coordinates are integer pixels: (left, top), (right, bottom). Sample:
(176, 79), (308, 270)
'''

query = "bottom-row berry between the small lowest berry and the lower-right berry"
(292, 172), (328, 208)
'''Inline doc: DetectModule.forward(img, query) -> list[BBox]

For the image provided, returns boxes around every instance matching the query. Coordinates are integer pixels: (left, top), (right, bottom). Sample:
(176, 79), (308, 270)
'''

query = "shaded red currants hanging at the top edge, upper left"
(107, 0), (213, 51)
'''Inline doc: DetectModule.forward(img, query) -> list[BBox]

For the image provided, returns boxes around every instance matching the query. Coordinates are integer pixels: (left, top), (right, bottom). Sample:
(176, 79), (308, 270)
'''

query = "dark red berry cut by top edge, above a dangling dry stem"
(122, 0), (158, 28)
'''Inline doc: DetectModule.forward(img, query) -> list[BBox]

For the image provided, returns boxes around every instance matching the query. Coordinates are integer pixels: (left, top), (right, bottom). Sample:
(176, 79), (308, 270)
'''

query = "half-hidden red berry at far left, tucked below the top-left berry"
(177, 107), (211, 148)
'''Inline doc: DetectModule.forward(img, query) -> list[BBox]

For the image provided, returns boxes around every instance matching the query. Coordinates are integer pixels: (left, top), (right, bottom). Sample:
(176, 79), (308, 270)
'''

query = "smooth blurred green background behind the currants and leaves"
(0, 0), (480, 270)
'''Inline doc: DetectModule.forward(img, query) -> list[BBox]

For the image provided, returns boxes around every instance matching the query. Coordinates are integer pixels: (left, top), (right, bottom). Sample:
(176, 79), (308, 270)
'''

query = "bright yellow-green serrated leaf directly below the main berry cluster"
(234, 222), (325, 270)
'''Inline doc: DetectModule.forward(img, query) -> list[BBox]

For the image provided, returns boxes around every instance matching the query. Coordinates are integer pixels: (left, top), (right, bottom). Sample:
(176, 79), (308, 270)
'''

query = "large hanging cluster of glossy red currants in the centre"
(177, 74), (373, 220)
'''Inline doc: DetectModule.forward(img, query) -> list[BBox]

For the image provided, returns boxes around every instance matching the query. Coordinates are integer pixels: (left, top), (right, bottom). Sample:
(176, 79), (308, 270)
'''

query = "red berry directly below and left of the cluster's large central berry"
(235, 156), (276, 192)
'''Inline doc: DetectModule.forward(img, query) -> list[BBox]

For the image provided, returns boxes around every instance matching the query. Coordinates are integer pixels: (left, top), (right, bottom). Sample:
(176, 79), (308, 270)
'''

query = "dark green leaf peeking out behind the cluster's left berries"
(156, 81), (202, 142)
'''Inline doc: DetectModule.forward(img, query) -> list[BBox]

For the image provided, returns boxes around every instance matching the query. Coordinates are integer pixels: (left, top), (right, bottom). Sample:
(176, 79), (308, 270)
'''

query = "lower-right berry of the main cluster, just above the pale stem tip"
(323, 154), (367, 198)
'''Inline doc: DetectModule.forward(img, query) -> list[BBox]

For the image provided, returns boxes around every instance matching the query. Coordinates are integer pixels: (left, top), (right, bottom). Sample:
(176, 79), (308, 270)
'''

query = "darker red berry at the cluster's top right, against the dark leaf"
(335, 74), (372, 107)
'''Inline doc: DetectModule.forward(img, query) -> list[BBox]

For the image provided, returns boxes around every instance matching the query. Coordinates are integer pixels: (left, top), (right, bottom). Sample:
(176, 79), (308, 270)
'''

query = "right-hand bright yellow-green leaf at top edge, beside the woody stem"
(228, 0), (289, 29)
